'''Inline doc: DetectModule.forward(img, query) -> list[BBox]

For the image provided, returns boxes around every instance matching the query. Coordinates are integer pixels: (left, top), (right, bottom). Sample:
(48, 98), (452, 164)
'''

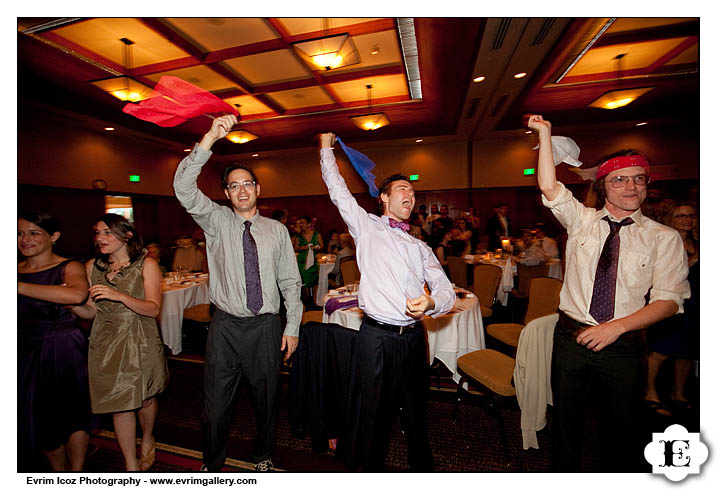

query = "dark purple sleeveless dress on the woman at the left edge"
(17, 259), (92, 467)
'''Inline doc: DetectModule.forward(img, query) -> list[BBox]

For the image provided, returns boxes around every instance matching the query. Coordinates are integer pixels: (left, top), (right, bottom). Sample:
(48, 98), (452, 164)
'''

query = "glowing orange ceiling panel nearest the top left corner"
(53, 18), (188, 67)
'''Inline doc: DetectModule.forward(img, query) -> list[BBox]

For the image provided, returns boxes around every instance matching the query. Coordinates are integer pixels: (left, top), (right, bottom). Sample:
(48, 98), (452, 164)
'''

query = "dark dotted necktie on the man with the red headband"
(588, 217), (633, 324)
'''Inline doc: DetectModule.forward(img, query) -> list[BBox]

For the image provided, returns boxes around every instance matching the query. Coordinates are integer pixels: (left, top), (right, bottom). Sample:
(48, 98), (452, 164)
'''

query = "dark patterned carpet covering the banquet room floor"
(77, 359), (698, 472)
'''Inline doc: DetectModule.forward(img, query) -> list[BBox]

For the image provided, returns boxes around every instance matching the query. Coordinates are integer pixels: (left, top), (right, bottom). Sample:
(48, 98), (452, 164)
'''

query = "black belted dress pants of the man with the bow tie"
(356, 322), (434, 471)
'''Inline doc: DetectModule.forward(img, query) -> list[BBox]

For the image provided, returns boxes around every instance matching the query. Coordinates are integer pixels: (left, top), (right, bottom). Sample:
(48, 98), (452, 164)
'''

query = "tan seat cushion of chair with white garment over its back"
(458, 349), (516, 396)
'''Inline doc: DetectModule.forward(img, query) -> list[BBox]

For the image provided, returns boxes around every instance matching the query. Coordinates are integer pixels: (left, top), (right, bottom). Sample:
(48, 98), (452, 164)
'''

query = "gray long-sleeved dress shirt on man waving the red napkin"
(174, 145), (303, 336)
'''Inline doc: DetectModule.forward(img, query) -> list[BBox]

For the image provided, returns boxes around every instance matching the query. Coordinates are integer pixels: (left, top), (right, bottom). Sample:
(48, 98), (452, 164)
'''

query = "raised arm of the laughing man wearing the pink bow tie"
(319, 133), (369, 240)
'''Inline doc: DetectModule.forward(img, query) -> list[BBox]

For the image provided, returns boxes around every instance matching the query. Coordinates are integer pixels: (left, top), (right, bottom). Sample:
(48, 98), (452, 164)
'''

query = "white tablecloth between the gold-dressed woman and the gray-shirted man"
(158, 278), (209, 355)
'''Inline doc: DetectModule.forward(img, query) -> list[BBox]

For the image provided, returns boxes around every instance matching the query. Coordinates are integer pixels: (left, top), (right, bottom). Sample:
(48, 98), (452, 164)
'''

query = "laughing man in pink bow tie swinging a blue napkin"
(320, 133), (456, 471)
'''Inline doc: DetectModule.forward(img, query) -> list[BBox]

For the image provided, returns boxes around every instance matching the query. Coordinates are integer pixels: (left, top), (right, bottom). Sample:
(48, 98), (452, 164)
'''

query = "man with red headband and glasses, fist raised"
(528, 115), (690, 472)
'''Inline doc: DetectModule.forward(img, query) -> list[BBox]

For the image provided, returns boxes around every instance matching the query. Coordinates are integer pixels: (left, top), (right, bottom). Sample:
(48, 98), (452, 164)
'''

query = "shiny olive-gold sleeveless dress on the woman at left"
(88, 251), (169, 413)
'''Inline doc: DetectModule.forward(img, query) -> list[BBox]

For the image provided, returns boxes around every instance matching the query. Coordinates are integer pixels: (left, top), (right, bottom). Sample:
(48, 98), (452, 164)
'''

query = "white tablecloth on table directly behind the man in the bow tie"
(322, 294), (486, 383)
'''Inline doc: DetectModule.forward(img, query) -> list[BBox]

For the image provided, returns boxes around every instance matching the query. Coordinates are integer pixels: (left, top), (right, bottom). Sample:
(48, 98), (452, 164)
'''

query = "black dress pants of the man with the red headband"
(551, 315), (648, 472)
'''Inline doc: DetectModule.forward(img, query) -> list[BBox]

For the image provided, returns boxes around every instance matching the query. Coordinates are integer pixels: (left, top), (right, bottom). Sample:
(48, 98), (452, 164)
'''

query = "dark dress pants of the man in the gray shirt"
(201, 309), (282, 471)
